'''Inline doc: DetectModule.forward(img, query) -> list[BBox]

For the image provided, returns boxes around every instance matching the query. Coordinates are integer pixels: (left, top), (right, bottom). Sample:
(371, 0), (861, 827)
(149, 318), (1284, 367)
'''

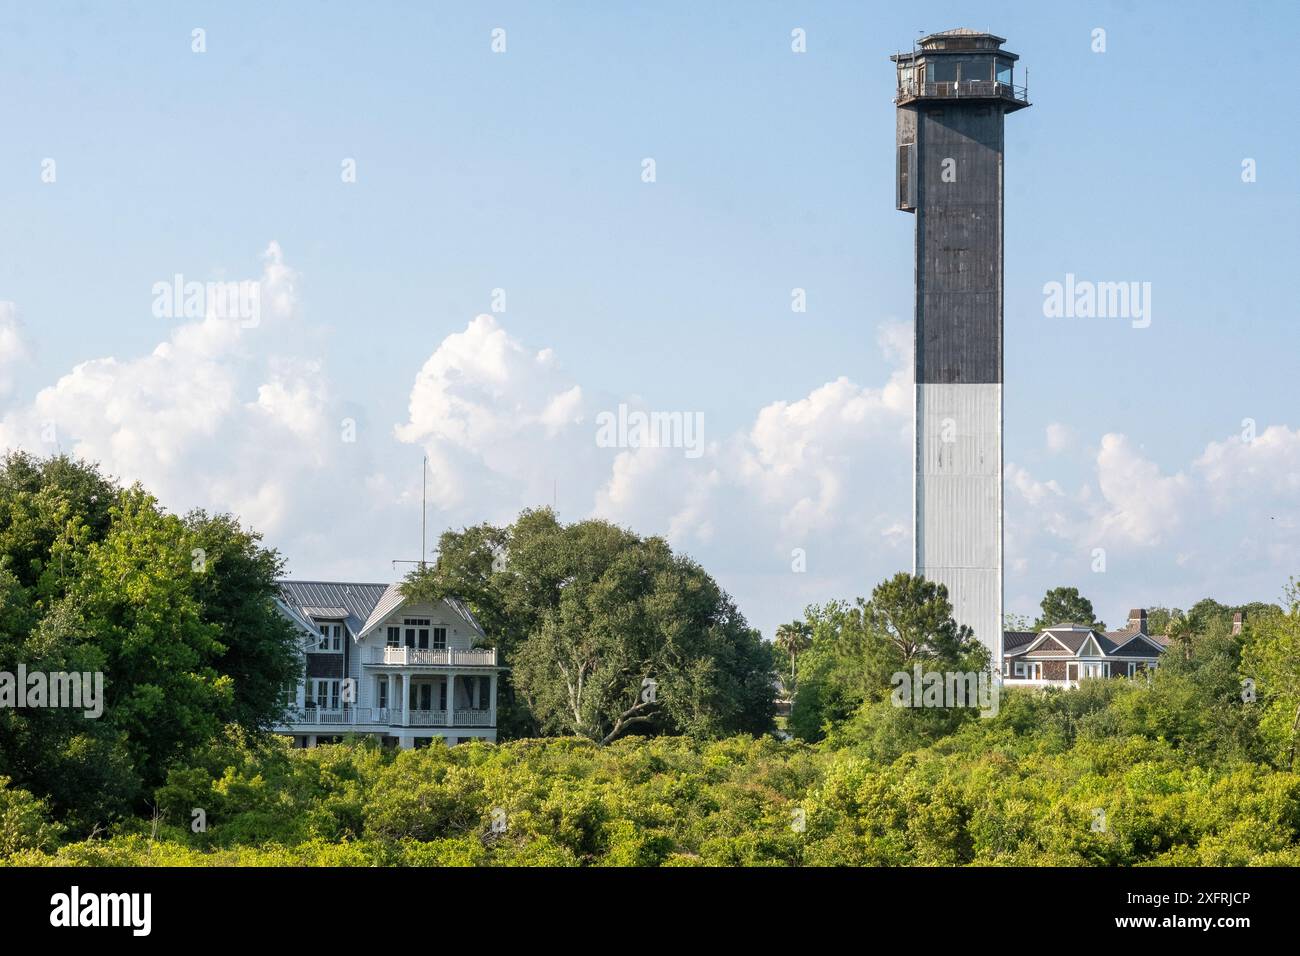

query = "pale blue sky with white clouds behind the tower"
(0, 1), (1300, 642)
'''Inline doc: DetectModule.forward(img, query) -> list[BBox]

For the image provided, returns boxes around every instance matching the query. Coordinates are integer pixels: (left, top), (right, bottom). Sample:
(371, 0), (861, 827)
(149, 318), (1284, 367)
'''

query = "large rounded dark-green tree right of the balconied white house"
(404, 510), (774, 743)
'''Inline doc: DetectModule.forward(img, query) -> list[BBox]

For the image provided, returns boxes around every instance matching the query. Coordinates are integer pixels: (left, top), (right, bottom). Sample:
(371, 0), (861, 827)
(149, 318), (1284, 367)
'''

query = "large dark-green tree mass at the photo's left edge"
(0, 454), (298, 830)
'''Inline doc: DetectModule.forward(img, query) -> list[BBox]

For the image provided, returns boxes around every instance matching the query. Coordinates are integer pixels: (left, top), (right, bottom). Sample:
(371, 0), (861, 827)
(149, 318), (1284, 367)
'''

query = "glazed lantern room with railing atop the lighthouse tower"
(889, 29), (1030, 113)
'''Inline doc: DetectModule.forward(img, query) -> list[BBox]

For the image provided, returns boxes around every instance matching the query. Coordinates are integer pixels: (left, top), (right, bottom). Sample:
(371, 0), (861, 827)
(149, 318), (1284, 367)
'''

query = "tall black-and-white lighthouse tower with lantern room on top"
(891, 30), (1030, 660)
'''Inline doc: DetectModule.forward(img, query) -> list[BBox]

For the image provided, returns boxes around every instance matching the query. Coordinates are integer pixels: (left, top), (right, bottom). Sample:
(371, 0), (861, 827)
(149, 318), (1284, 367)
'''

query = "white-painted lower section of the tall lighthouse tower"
(913, 385), (1002, 674)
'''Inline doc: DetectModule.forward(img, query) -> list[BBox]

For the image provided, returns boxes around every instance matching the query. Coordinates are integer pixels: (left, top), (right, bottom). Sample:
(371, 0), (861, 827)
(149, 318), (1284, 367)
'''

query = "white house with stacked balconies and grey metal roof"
(274, 580), (503, 748)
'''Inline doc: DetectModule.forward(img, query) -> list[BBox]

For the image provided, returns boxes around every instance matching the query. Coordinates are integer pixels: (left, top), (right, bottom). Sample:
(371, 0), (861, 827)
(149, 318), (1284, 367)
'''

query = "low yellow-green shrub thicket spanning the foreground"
(10, 680), (1300, 865)
